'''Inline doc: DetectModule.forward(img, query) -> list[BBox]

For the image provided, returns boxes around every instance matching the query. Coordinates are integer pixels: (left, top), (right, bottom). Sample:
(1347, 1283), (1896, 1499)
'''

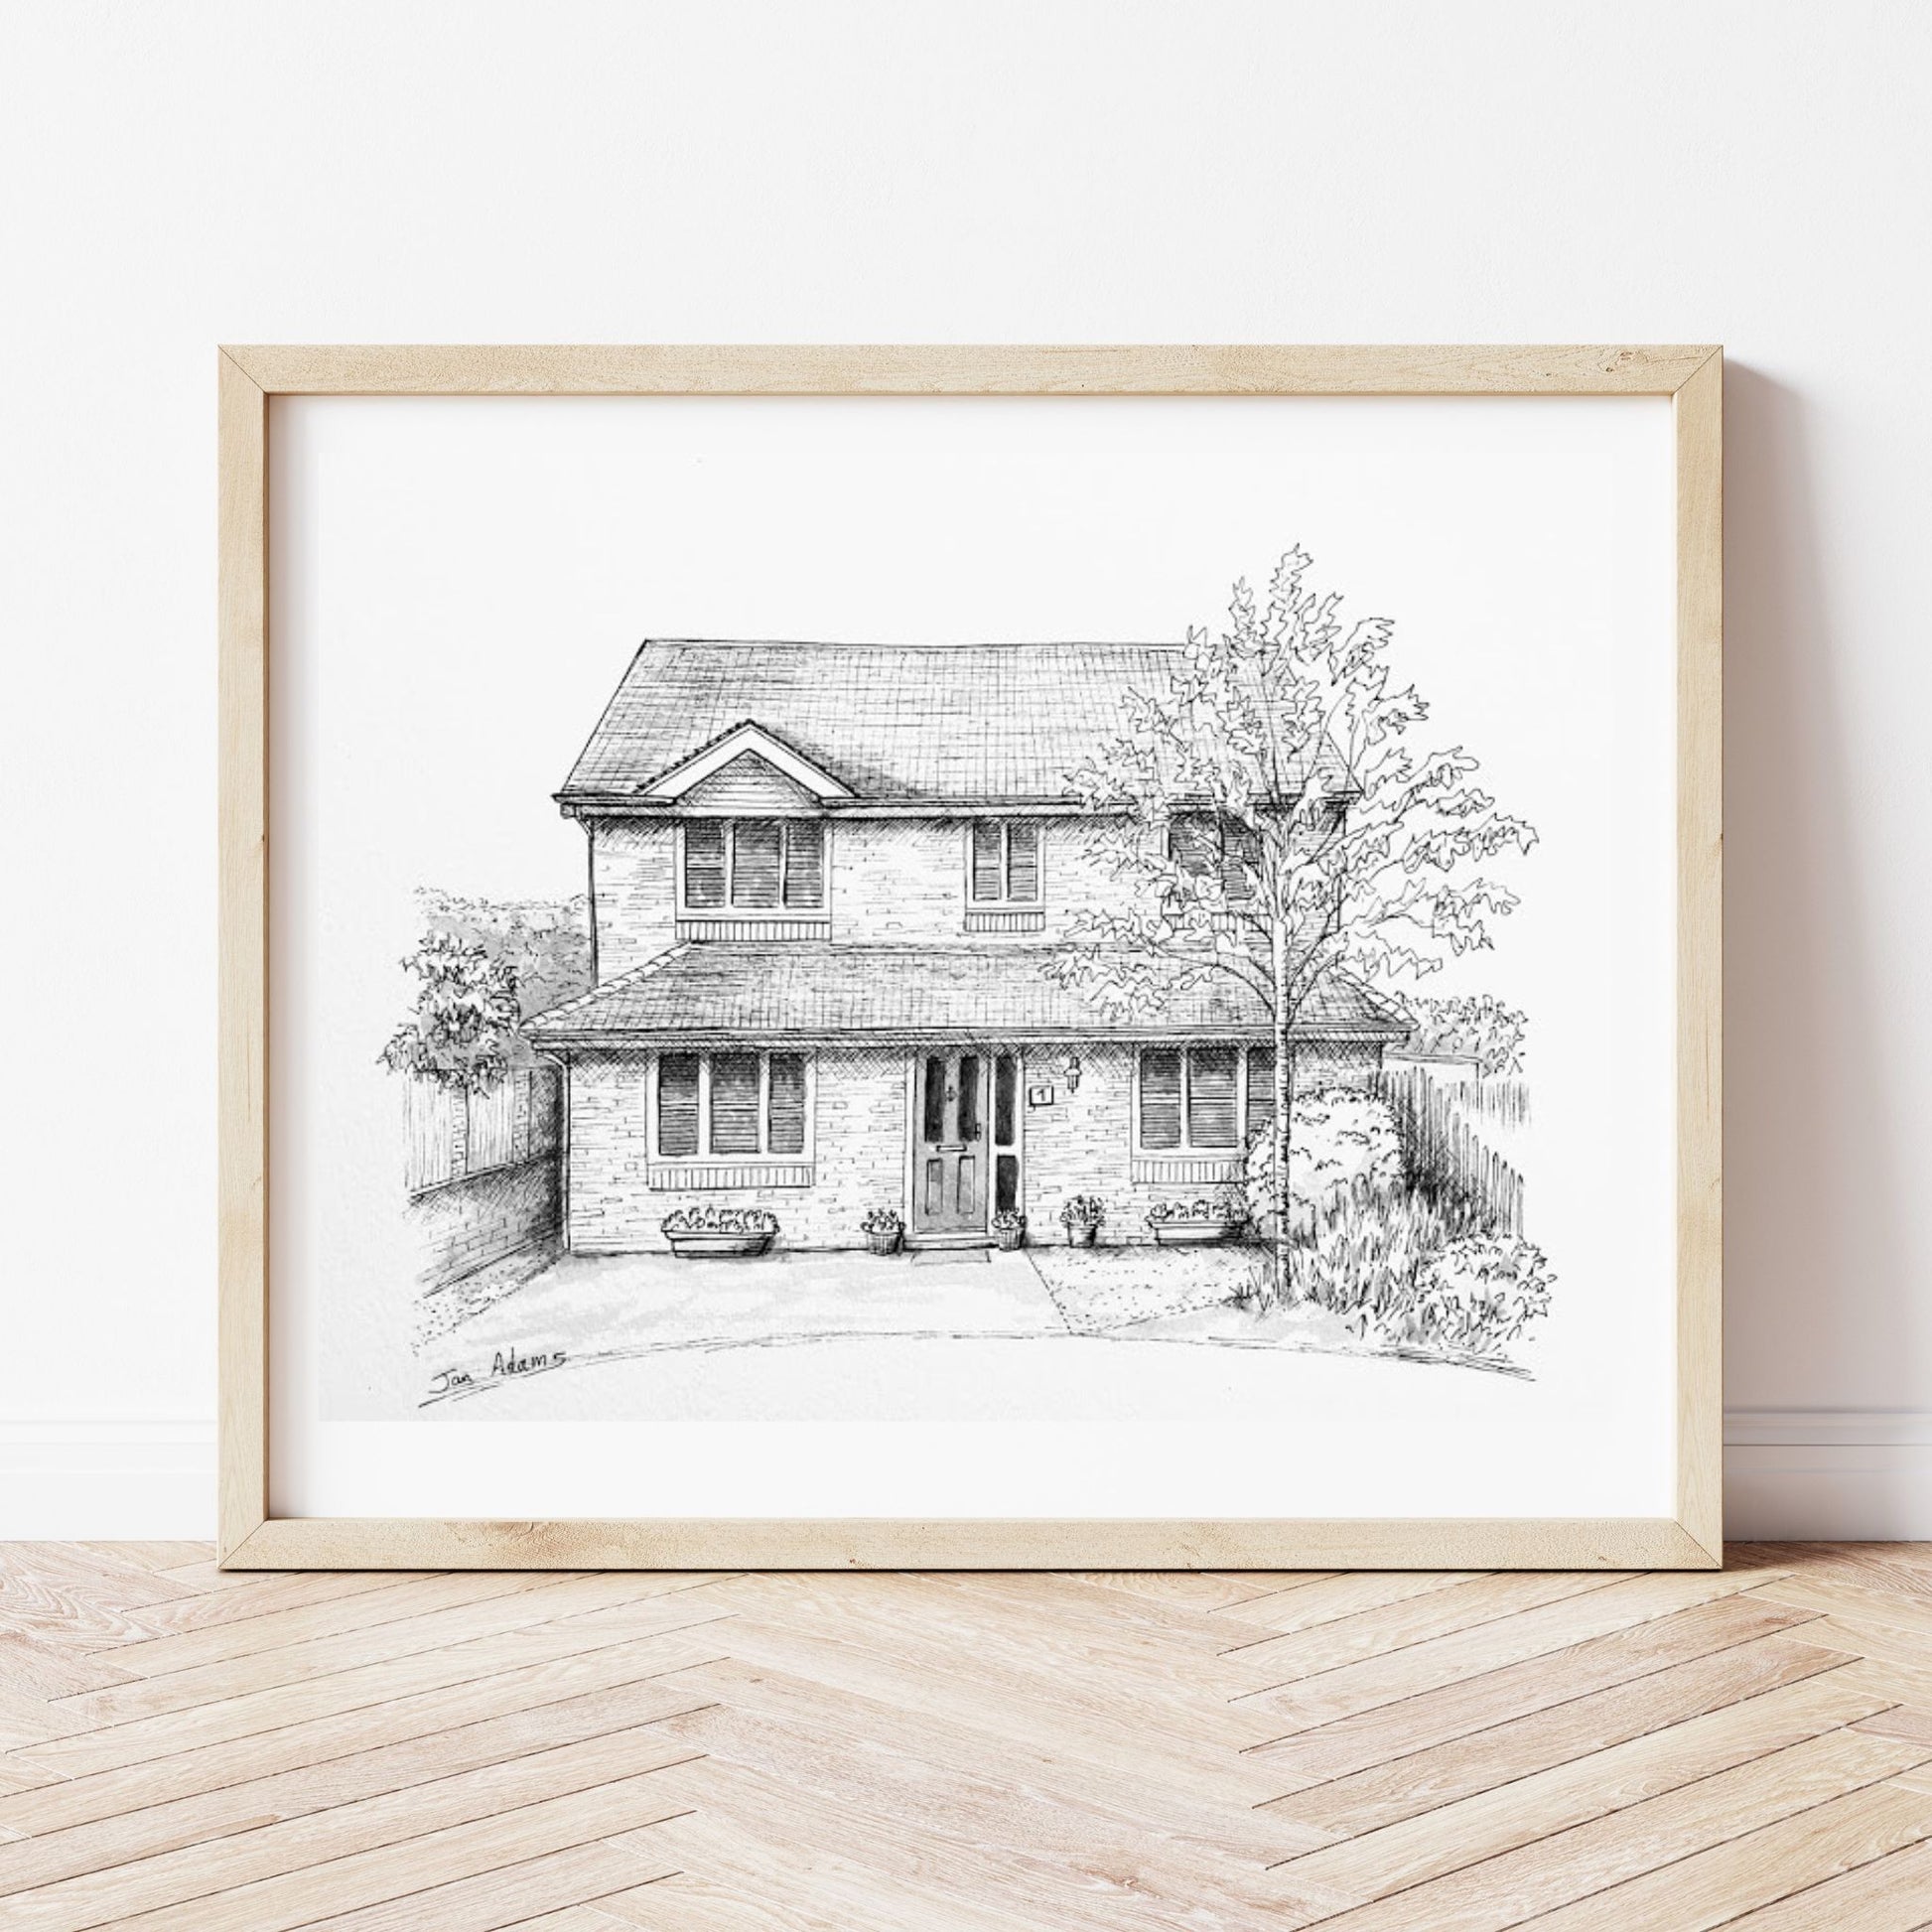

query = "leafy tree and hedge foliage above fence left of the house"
(380, 891), (591, 1093)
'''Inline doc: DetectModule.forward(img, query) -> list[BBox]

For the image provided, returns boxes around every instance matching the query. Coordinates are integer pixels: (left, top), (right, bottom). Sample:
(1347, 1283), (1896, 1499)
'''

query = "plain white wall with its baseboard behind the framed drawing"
(0, 0), (1932, 1536)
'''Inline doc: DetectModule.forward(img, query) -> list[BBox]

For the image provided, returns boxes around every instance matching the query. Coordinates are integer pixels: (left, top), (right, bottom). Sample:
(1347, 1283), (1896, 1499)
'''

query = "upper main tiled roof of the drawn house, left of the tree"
(556, 639), (1180, 809)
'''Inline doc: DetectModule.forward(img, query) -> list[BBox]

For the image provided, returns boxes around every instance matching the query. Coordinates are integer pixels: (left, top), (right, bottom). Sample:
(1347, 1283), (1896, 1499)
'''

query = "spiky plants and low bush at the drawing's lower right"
(1289, 1178), (1552, 1362)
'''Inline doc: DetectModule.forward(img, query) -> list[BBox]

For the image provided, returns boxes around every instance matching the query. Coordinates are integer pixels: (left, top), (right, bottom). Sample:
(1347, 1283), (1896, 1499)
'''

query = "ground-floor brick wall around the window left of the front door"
(570, 1047), (906, 1254)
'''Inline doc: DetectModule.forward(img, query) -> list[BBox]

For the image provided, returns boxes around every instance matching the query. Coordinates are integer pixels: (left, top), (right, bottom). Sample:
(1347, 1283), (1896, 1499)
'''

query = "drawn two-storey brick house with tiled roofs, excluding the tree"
(529, 641), (1407, 1252)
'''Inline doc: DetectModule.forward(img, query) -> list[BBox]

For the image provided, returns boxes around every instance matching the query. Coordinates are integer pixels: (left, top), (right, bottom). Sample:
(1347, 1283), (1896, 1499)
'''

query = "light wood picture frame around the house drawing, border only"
(218, 345), (1724, 1571)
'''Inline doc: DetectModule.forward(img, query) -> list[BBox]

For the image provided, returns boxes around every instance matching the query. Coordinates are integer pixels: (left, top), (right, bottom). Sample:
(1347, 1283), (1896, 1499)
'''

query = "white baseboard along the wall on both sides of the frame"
(0, 1409), (1932, 1542)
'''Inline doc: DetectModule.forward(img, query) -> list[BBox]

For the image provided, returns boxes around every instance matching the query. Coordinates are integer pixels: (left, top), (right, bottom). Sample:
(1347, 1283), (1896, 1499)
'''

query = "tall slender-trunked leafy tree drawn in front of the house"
(1056, 547), (1536, 1301)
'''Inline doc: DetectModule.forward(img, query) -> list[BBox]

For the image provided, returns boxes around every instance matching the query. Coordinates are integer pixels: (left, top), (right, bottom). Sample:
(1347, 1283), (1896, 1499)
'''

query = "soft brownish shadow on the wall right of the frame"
(1724, 363), (1928, 1409)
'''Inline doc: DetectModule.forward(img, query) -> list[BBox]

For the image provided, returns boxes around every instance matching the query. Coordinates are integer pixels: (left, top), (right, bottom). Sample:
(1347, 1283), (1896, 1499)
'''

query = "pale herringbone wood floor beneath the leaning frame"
(0, 1544), (1932, 1932)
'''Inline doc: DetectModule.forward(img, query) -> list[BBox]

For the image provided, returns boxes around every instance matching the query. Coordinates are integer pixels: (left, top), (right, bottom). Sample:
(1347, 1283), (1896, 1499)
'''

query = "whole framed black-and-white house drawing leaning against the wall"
(220, 347), (1722, 1569)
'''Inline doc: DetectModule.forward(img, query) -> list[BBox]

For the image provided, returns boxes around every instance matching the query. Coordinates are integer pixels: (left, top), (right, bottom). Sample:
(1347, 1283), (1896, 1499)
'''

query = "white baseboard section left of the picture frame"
(0, 1418), (214, 1542)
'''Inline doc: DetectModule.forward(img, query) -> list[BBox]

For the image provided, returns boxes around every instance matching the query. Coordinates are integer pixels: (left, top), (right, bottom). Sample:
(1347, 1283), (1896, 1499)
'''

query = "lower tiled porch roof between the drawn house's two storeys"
(523, 941), (1411, 1047)
